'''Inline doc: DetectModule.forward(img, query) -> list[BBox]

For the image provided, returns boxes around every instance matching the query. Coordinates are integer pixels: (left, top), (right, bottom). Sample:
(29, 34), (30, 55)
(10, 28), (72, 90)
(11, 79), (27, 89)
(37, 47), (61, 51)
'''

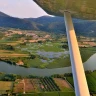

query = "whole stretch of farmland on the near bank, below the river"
(0, 71), (96, 96)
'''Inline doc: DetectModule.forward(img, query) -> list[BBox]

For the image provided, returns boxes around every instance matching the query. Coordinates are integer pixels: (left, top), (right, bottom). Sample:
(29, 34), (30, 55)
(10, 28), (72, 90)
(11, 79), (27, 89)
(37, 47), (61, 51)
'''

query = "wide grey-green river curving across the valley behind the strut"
(0, 54), (96, 76)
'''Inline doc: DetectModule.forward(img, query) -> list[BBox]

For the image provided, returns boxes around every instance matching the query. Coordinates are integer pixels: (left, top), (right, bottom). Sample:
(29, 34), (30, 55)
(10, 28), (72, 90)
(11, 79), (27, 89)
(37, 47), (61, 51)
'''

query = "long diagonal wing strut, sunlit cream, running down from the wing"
(64, 11), (90, 96)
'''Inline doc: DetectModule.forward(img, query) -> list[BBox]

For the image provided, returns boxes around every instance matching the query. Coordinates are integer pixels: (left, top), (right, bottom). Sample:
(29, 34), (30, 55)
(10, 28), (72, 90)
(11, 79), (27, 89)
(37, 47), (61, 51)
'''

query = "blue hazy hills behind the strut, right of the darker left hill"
(27, 16), (96, 36)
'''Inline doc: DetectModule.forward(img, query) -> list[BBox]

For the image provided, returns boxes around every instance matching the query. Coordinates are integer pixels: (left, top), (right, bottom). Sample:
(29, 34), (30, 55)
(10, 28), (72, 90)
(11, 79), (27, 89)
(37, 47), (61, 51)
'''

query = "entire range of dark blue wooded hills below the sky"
(0, 12), (96, 36)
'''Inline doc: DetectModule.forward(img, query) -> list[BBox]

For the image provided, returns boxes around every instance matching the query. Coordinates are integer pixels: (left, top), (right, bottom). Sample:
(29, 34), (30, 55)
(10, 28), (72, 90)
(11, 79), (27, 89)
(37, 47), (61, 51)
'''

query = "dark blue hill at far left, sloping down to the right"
(0, 12), (34, 29)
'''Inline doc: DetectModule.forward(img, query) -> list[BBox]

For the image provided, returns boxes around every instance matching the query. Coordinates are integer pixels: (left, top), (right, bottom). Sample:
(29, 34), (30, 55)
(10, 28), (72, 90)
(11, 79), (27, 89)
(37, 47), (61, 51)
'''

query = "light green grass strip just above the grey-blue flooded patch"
(20, 41), (63, 52)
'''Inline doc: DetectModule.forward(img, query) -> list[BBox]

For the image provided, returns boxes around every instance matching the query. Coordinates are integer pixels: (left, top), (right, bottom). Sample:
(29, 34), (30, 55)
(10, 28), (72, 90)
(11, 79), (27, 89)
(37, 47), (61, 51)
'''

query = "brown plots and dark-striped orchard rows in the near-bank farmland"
(13, 77), (73, 93)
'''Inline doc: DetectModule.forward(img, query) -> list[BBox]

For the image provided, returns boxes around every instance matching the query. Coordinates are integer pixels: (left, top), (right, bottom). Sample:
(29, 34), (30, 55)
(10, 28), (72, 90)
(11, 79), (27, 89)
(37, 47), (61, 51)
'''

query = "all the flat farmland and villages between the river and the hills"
(0, 29), (96, 69)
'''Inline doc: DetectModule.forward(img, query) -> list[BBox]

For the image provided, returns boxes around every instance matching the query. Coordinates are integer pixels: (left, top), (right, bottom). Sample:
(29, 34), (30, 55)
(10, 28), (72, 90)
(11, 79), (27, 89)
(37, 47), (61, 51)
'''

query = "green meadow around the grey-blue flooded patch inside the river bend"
(9, 42), (96, 68)
